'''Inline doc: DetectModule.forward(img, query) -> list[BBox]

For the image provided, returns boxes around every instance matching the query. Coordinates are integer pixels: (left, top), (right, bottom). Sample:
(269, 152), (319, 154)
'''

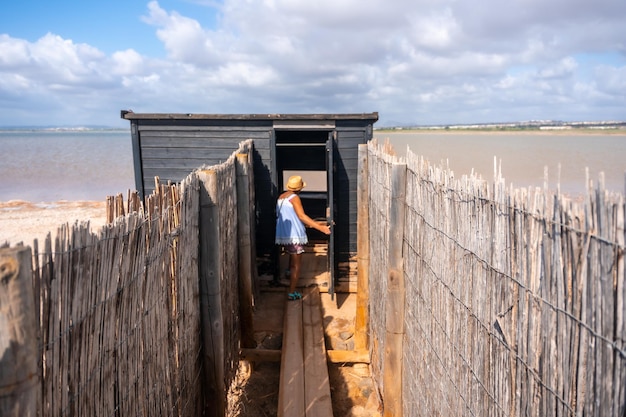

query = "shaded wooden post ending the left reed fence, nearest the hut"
(236, 153), (256, 348)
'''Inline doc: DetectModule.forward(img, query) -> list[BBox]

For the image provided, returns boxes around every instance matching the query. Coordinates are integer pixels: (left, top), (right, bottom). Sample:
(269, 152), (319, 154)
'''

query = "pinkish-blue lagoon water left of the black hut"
(0, 130), (135, 202)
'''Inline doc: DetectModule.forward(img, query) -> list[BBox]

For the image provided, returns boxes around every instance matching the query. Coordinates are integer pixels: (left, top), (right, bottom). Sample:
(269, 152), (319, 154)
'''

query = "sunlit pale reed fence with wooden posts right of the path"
(367, 143), (626, 416)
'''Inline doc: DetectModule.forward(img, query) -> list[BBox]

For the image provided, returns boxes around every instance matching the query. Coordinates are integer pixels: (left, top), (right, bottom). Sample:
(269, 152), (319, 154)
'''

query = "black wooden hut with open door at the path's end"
(121, 111), (378, 291)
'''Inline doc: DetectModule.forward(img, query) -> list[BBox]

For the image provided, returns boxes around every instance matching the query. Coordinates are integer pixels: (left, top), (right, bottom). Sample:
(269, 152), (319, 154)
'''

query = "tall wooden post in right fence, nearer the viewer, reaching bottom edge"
(383, 162), (406, 417)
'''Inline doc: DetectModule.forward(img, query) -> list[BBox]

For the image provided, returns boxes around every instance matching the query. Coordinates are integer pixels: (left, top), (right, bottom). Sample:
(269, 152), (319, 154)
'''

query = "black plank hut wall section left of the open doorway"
(132, 120), (276, 253)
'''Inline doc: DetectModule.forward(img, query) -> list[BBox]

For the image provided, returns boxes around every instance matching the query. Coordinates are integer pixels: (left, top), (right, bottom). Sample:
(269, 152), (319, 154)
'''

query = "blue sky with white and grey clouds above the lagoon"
(0, 0), (626, 127)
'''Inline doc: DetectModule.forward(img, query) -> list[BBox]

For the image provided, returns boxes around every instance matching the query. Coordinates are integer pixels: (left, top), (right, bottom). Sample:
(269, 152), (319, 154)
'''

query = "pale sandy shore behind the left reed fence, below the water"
(0, 200), (106, 246)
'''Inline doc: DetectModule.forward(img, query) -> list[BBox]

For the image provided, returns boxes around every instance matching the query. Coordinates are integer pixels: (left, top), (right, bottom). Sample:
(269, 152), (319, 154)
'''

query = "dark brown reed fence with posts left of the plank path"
(0, 141), (255, 416)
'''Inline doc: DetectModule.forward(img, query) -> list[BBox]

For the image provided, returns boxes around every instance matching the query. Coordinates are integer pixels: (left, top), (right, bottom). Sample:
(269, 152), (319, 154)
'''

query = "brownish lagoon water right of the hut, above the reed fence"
(374, 130), (626, 195)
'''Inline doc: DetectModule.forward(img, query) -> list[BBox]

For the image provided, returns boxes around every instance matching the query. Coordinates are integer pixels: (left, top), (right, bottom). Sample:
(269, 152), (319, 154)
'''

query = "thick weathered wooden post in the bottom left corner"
(0, 246), (41, 417)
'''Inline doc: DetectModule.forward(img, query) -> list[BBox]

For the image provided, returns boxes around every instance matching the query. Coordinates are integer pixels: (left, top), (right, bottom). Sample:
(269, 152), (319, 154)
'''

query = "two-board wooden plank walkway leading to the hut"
(278, 287), (333, 417)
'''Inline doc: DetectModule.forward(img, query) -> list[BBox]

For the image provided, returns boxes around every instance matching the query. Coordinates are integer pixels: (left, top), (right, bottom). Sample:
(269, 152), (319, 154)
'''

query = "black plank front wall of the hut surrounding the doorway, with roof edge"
(122, 112), (378, 270)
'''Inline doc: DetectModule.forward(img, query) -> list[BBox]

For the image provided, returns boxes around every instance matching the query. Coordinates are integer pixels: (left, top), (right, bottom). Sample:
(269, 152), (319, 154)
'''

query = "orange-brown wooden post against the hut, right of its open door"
(354, 144), (370, 351)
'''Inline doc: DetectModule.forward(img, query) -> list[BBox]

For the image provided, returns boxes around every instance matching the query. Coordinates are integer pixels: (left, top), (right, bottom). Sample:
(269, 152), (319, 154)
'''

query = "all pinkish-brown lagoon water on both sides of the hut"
(0, 129), (626, 202)
